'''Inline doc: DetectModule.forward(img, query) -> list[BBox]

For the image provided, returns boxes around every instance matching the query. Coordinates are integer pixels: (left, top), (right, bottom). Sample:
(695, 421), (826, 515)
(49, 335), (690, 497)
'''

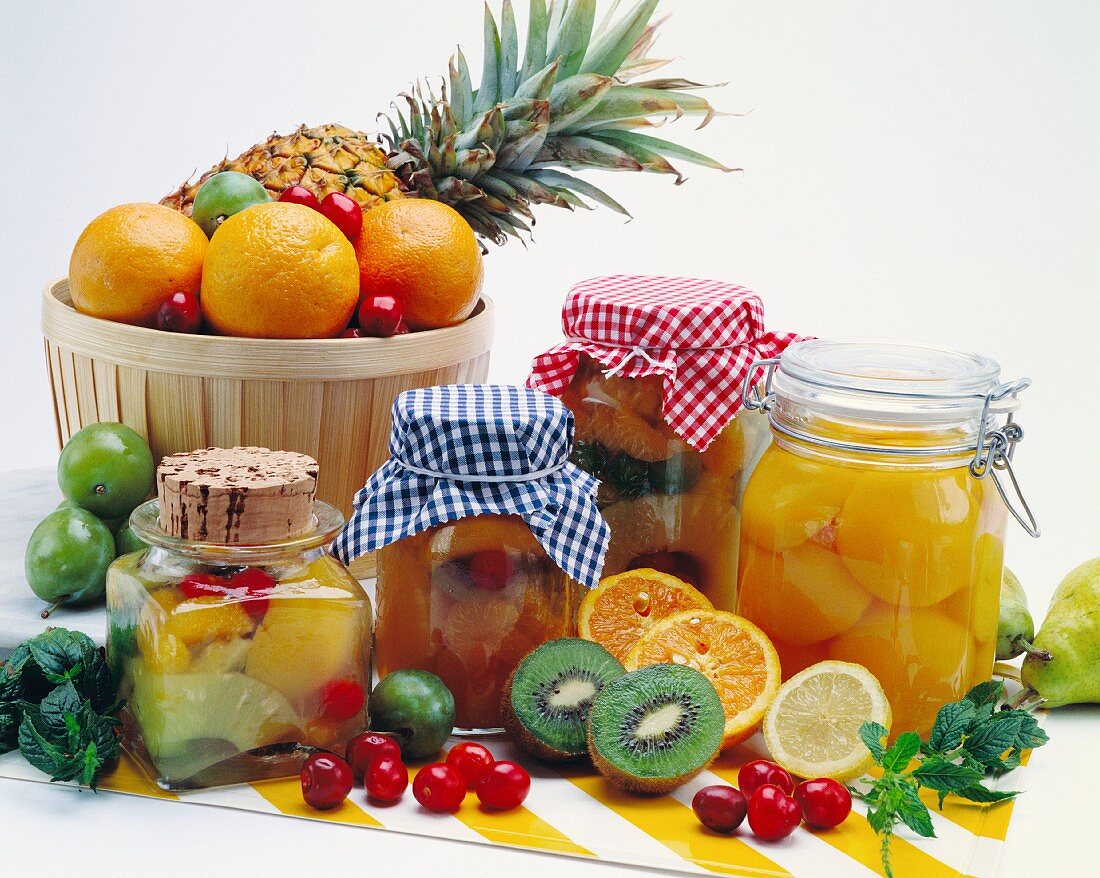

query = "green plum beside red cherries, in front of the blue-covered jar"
(369, 668), (454, 759)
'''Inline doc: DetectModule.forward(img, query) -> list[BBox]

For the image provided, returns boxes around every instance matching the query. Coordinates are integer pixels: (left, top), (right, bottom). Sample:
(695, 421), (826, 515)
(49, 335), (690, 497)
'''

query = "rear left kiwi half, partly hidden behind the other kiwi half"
(501, 637), (624, 762)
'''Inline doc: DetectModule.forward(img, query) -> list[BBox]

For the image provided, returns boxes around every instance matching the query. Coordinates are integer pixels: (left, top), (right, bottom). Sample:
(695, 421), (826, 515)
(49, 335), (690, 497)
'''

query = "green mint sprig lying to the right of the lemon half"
(854, 680), (1048, 878)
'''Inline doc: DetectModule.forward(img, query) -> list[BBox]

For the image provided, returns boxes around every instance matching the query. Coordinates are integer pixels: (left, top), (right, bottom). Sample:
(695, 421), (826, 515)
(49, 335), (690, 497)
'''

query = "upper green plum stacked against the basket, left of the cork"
(57, 422), (155, 520)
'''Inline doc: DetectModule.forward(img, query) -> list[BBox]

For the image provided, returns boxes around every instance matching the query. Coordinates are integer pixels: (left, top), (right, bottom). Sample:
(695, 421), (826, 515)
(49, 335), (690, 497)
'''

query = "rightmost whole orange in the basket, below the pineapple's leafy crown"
(355, 198), (484, 329)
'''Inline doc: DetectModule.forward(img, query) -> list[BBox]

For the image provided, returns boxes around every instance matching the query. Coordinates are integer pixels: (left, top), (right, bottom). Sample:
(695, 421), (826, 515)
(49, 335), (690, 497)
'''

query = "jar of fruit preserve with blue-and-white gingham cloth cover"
(333, 385), (609, 734)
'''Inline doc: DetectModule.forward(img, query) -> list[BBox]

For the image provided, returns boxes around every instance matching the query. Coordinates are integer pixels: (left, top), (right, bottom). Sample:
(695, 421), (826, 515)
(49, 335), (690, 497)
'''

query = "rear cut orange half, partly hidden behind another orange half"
(576, 567), (712, 661)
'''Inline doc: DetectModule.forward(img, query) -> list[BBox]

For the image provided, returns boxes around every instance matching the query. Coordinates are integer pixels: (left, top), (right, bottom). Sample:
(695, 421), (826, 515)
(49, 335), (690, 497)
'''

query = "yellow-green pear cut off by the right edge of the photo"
(1020, 558), (1100, 707)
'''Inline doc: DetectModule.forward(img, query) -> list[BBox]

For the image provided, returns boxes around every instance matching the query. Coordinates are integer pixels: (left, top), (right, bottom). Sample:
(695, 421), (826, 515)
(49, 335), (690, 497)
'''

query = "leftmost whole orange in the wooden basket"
(69, 204), (207, 327)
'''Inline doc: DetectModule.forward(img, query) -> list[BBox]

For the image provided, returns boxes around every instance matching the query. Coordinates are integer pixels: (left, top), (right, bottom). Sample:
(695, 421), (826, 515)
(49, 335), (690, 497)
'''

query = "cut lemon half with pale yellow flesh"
(763, 661), (891, 780)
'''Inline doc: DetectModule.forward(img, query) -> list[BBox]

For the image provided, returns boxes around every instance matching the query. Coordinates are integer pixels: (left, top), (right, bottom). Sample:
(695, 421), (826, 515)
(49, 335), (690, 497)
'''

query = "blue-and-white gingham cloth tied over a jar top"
(333, 384), (611, 588)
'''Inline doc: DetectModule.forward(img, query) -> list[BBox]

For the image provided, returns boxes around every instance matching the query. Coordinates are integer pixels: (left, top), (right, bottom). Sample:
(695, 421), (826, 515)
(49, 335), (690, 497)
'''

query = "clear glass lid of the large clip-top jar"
(771, 339), (1019, 429)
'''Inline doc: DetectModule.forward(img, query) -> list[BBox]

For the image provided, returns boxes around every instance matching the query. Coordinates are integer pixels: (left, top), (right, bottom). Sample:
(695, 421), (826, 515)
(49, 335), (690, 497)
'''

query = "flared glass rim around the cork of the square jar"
(130, 500), (344, 564)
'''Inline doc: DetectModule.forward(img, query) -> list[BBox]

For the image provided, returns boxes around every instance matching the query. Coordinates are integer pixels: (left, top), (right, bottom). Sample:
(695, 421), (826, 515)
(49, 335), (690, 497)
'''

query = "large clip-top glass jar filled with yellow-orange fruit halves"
(738, 340), (1037, 733)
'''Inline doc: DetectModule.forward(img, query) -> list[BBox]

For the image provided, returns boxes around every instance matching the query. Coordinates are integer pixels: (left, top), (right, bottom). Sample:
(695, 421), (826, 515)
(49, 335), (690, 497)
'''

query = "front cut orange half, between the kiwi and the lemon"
(623, 610), (780, 749)
